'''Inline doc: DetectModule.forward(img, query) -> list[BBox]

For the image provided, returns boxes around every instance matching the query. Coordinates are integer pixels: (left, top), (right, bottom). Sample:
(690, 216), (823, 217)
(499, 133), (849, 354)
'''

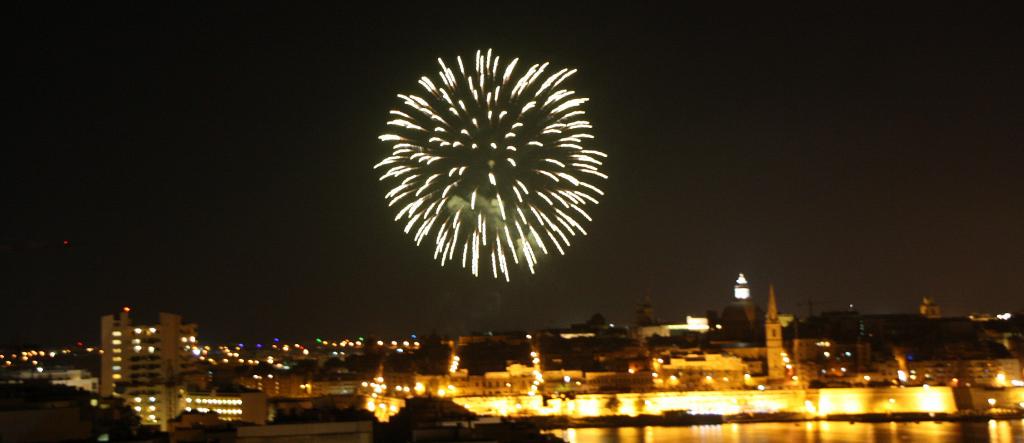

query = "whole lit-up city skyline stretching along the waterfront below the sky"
(6, 292), (1024, 433)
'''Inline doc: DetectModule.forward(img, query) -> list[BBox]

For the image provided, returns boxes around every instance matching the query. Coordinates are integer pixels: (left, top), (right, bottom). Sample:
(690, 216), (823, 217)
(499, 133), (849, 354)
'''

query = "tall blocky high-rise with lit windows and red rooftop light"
(99, 307), (199, 430)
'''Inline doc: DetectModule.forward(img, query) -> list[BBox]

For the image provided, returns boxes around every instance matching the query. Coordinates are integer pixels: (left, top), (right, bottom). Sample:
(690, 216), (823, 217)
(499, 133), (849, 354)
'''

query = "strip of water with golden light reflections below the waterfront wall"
(551, 419), (1024, 443)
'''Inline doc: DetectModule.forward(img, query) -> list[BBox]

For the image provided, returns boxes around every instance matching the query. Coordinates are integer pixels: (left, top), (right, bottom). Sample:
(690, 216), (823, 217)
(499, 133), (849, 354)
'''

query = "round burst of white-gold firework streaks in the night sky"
(374, 49), (607, 281)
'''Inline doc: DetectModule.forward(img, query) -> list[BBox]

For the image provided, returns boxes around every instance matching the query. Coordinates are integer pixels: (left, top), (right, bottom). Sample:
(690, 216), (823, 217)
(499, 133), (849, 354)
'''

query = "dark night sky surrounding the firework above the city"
(0, 2), (1024, 343)
